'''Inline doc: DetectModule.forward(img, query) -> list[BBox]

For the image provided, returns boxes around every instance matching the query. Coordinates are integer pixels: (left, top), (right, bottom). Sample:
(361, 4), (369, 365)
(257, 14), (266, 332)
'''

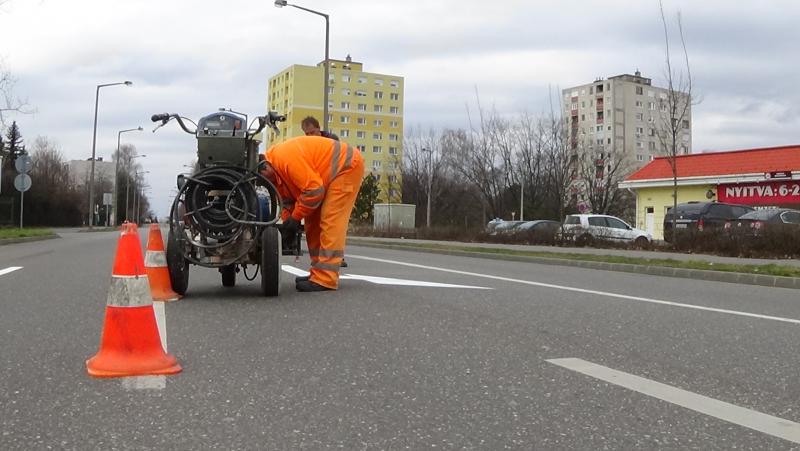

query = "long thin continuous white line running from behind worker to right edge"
(347, 254), (800, 324)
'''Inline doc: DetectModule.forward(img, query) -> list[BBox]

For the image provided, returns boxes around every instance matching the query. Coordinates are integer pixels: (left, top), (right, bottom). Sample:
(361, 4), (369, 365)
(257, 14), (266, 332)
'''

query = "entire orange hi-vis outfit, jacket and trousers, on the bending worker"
(266, 136), (364, 289)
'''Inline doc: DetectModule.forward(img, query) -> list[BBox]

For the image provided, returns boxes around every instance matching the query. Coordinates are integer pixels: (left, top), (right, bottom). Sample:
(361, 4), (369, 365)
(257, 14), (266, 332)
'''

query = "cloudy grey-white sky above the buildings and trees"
(0, 0), (800, 216)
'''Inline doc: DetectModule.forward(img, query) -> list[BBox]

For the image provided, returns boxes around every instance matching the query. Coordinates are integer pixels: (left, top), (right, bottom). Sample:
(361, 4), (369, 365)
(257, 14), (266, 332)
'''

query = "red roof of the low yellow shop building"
(625, 145), (800, 182)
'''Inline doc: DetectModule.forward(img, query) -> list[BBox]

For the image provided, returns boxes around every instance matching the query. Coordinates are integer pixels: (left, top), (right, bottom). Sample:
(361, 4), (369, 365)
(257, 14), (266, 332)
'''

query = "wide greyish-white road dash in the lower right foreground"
(548, 358), (800, 443)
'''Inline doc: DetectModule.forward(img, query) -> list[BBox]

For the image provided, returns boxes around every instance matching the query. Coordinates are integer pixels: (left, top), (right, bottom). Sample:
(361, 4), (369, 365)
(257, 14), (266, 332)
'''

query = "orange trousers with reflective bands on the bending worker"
(305, 159), (364, 289)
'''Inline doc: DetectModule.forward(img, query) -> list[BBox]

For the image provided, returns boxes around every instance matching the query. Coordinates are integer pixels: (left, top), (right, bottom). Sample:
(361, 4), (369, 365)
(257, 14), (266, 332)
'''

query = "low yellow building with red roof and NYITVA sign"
(620, 145), (800, 239)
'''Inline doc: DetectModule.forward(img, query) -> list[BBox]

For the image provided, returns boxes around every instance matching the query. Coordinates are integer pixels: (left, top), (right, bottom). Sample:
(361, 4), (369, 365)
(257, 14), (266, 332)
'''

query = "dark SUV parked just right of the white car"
(664, 202), (754, 242)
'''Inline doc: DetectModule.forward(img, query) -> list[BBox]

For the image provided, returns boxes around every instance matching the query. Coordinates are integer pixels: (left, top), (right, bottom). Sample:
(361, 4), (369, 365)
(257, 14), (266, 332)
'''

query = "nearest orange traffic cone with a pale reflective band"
(86, 224), (181, 377)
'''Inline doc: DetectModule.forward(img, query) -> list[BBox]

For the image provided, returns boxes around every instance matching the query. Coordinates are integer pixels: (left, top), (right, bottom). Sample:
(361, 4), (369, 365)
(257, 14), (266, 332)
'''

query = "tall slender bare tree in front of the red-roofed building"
(656, 0), (697, 242)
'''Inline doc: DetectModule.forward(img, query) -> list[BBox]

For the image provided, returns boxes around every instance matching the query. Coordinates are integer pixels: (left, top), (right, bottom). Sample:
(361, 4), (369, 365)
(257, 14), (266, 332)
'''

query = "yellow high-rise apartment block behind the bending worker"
(264, 55), (403, 202)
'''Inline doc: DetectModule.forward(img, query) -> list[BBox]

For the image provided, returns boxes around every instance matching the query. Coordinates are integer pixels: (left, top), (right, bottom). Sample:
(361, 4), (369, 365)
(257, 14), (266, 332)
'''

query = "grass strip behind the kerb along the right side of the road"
(354, 238), (800, 277)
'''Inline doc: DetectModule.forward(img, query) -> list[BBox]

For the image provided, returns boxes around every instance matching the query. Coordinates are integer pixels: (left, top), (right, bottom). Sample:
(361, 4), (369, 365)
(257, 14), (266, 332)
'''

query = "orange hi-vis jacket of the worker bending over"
(265, 136), (363, 221)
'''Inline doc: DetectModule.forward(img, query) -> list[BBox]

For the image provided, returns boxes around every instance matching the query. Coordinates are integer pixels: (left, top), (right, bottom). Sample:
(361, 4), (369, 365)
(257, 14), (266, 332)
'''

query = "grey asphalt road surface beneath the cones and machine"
(0, 231), (800, 450)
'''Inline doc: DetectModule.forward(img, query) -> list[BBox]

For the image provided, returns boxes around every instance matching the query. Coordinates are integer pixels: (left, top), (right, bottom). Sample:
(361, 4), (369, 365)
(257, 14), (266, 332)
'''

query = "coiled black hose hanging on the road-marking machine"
(170, 166), (280, 267)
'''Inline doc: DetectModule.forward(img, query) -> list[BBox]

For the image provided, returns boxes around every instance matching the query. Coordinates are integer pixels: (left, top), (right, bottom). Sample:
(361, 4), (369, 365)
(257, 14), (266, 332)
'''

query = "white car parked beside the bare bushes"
(563, 215), (653, 247)
